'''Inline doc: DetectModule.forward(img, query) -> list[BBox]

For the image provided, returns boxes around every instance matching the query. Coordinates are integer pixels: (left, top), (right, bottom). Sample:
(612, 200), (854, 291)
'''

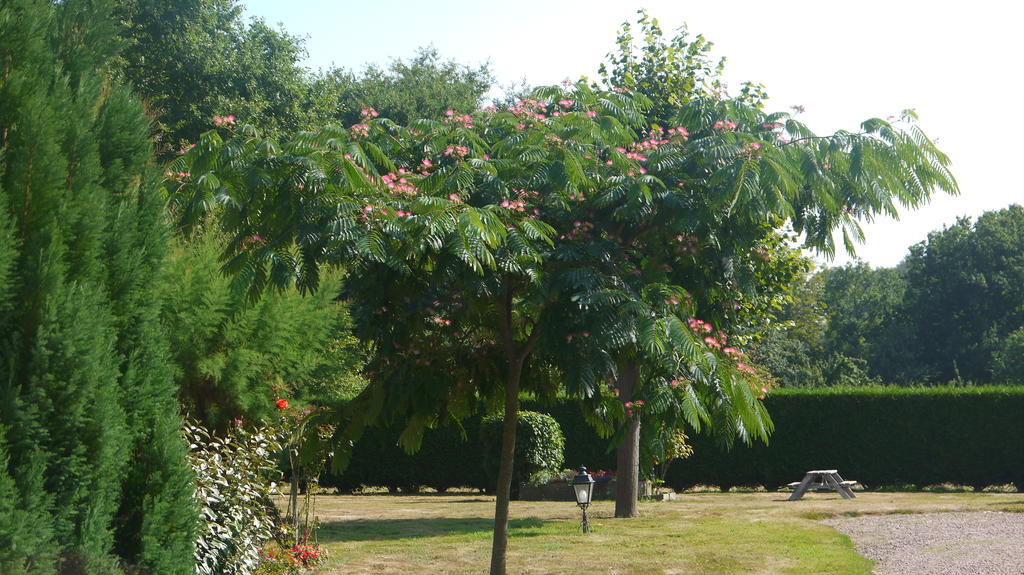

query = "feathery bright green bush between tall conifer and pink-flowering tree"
(160, 232), (350, 430)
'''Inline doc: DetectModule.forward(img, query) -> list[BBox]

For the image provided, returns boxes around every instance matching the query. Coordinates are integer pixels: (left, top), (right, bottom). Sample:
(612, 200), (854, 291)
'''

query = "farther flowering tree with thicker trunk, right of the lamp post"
(595, 11), (956, 517)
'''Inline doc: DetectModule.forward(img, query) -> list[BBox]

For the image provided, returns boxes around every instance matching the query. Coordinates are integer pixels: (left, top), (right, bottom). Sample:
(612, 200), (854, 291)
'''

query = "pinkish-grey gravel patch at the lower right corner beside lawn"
(822, 512), (1024, 575)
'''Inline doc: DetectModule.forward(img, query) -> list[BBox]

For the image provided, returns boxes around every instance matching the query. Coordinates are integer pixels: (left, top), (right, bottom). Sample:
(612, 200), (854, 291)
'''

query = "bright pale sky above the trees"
(242, 0), (1024, 267)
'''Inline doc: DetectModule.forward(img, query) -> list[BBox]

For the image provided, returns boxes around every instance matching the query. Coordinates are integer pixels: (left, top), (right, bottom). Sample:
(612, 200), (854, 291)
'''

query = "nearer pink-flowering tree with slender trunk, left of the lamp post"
(171, 85), (757, 573)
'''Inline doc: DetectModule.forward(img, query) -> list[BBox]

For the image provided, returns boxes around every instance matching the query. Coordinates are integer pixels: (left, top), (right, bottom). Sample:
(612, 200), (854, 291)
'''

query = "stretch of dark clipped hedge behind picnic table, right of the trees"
(667, 387), (1024, 491)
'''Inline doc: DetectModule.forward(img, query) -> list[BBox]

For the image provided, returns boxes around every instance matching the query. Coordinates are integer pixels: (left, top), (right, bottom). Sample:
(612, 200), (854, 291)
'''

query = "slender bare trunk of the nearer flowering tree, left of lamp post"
(490, 358), (522, 575)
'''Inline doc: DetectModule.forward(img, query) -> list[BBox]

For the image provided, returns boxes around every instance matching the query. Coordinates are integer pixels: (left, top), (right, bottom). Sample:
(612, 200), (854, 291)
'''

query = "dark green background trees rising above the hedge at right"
(756, 206), (1024, 387)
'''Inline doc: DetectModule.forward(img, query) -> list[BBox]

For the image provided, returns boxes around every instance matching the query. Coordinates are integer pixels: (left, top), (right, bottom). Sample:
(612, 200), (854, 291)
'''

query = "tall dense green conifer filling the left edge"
(0, 0), (196, 575)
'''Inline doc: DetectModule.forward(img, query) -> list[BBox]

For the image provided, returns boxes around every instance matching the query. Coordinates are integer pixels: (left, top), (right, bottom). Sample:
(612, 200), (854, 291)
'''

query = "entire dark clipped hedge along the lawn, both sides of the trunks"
(324, 387), (1024, 490)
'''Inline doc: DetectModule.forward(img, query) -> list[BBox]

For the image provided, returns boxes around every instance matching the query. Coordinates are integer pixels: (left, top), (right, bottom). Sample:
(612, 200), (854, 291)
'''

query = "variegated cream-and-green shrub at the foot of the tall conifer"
(184, 415), (282, 575)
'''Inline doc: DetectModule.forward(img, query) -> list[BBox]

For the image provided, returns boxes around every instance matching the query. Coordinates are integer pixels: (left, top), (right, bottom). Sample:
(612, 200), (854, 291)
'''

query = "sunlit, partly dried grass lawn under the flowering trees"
(307, 487), (1024, 575)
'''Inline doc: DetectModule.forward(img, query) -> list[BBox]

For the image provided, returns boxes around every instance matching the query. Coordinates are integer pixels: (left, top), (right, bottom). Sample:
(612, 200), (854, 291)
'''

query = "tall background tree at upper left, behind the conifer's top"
(116, 0), (328, 160)
